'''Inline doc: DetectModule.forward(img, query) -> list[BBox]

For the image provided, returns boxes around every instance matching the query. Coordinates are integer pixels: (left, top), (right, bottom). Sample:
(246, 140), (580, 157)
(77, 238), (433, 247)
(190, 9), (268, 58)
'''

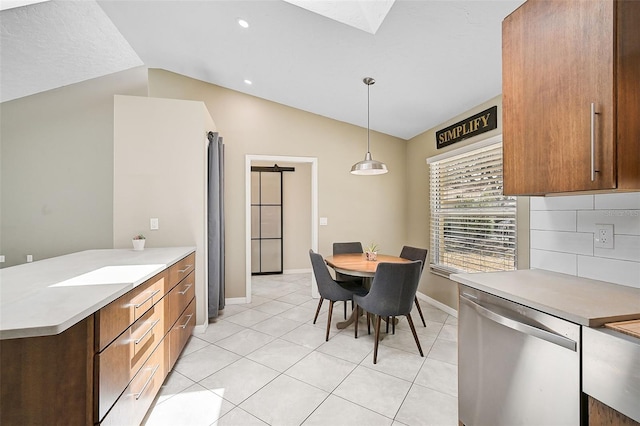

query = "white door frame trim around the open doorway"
(245, 155), (318, 303)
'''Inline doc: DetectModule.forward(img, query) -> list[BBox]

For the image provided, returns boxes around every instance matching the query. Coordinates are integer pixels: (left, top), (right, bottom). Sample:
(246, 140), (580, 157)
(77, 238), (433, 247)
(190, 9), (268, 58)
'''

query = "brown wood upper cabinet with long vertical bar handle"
(502, 0), (640, 195)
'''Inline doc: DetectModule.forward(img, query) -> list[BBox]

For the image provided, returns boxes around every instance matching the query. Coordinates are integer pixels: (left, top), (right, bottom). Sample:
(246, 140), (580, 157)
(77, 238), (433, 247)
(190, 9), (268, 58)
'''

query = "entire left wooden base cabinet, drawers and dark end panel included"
(0, 253), (196, 426)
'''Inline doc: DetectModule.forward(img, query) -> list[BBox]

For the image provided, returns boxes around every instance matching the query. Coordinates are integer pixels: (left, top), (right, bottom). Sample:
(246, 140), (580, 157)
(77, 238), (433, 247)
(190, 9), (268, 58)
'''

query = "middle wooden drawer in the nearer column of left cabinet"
(96, 303), (164, 418)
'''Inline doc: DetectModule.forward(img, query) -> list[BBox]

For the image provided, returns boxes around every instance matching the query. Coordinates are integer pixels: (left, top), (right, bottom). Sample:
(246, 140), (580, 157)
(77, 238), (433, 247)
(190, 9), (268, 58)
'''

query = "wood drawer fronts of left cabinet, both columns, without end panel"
(95, 253), (195, 425)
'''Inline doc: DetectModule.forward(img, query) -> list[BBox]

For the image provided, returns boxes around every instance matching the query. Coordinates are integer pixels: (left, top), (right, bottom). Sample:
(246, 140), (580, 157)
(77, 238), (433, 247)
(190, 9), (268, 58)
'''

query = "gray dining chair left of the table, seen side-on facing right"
(309, 250), (367, 341)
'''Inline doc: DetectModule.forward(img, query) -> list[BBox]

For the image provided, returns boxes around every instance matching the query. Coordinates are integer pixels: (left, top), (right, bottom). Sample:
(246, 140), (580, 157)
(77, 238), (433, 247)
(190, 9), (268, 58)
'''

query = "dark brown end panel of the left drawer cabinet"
(0, 315), (94, 426)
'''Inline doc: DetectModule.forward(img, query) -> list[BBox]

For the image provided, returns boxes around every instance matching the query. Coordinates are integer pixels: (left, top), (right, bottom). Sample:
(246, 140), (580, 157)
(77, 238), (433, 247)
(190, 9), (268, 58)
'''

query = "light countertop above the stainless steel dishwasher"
(450, 269), (640, 327)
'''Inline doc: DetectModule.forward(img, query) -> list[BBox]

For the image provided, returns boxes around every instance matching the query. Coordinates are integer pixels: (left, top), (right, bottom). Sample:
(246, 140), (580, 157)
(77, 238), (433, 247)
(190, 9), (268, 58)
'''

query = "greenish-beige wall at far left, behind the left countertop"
(0, 68), (147, 267)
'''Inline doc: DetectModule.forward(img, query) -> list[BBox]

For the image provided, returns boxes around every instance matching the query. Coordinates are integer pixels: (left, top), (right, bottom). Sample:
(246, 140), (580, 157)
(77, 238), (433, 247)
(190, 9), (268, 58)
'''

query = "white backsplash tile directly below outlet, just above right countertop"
(578, 256), (640, 288)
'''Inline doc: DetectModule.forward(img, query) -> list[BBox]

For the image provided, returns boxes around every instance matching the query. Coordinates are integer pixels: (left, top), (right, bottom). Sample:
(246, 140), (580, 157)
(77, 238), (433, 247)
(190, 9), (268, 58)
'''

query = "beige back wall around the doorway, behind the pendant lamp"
(149, 69), (407, 298)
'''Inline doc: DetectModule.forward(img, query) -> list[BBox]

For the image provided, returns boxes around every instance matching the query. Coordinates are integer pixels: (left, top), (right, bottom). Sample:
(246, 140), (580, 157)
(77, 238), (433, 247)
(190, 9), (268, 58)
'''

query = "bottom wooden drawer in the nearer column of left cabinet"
(100, 345), (166, 426)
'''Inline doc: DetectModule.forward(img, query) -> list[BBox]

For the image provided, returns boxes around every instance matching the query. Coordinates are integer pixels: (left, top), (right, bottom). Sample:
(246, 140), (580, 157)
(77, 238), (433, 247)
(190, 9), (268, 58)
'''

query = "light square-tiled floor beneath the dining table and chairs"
(145, 274), (458, 426)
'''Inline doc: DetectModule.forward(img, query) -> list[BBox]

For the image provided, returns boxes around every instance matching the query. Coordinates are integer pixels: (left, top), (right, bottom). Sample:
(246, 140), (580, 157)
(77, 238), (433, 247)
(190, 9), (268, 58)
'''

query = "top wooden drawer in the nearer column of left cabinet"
(96, 271), (167, 352)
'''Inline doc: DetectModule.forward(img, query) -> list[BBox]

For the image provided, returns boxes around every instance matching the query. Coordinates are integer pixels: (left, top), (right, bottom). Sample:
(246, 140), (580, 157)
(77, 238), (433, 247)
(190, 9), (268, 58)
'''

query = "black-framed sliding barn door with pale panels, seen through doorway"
(251, 164), (295, 275)
